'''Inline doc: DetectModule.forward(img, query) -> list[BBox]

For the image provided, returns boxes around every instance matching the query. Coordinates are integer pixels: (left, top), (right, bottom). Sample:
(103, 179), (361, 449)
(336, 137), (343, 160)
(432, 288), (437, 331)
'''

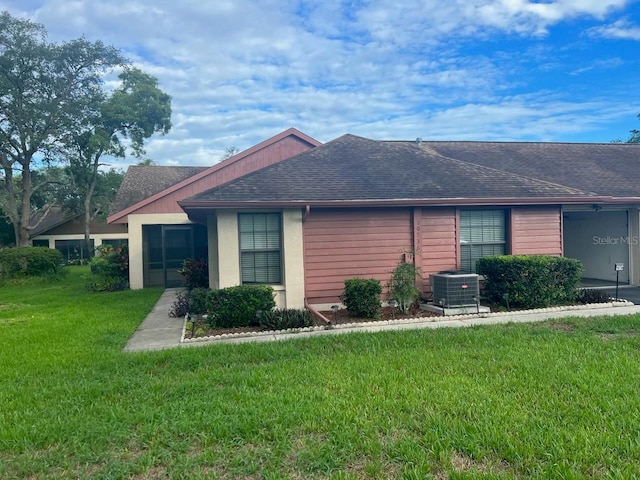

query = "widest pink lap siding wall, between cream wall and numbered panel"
(303, 208), (412, 304)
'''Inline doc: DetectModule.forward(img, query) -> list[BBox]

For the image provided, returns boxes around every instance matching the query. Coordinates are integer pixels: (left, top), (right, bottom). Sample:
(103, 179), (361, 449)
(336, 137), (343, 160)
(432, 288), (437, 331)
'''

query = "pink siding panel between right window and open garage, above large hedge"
(511, 207), (562, 255)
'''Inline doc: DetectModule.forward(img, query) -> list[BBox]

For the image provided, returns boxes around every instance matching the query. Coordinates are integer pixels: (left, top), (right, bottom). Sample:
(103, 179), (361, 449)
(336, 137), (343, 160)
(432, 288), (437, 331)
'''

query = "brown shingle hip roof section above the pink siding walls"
(180, 135), (608, 206)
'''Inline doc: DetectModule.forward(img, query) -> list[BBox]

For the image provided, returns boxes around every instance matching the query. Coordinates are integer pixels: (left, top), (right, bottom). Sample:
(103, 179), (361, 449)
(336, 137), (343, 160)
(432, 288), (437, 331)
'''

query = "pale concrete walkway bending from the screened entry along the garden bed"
(124, 289), (640, 352)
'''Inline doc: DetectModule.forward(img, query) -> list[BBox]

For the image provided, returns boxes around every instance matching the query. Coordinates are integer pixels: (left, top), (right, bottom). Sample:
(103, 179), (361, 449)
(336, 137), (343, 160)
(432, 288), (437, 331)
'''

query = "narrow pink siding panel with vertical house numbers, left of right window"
(418, 208), (458, 292)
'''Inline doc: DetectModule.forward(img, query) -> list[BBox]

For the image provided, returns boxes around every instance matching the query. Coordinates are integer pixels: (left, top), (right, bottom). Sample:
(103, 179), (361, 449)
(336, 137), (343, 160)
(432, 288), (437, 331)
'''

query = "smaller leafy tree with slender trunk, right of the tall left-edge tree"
(66, 67), (171, 258)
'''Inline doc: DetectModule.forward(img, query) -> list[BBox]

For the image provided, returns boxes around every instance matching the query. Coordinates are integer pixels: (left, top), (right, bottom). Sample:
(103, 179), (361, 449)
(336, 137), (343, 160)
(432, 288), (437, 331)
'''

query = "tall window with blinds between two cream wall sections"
(238, 213), (282, 284)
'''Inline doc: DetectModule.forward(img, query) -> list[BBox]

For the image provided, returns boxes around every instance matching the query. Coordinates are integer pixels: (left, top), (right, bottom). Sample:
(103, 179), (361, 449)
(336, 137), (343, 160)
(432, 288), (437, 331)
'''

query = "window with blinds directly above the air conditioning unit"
(460, 209), (507, 272)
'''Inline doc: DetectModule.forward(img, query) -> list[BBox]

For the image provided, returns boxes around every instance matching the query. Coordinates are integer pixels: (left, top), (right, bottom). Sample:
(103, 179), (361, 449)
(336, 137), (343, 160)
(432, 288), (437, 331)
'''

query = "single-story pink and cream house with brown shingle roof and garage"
(108, 130), (640, 308)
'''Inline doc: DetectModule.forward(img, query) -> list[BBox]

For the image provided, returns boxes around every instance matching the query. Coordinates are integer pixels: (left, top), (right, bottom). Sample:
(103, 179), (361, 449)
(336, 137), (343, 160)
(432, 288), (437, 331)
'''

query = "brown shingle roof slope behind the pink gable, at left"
(109, 165), (207, 213)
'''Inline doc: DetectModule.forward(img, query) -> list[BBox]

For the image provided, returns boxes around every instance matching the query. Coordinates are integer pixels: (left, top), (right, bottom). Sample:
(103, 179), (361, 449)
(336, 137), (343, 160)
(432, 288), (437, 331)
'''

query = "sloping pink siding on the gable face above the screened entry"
(129, 135), (311, 214)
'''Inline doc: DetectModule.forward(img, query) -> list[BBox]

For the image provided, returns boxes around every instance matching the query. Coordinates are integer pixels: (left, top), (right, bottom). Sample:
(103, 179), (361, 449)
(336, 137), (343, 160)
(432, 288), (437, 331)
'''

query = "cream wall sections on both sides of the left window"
(208, 209), (305, 308)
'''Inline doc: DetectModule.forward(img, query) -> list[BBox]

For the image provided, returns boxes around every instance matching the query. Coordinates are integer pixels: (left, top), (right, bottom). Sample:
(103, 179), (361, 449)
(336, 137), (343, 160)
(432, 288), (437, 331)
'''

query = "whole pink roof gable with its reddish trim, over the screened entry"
(107, 128), (321, 223)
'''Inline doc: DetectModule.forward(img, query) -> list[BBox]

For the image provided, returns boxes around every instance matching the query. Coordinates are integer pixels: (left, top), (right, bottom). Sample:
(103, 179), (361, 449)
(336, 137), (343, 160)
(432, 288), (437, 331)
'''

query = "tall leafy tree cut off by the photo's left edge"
(0, 12), (124, 246)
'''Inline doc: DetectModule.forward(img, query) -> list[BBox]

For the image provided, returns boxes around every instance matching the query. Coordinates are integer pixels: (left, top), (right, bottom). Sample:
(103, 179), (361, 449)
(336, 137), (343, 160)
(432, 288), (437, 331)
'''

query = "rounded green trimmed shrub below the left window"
(206, 285), (276, 328)
